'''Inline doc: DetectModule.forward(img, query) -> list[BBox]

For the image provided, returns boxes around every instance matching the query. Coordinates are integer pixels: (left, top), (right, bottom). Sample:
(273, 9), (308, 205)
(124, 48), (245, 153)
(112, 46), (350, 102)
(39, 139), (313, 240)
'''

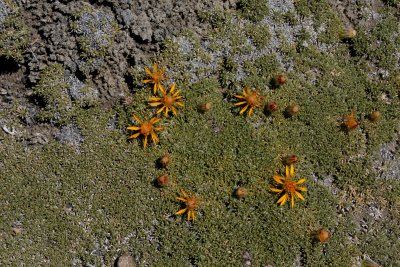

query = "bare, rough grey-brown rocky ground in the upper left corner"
(0, 1), (236, 146)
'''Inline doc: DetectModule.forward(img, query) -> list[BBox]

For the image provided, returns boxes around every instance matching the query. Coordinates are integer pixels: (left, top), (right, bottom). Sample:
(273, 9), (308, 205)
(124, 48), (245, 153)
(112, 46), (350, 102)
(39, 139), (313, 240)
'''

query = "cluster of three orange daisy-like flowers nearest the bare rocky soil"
(127, 64), (184, 147)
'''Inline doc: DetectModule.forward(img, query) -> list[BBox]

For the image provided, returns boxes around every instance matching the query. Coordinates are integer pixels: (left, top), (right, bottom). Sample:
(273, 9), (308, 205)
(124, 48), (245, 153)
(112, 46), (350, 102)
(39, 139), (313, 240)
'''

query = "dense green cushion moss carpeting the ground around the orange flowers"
(0, 1), (400, 266)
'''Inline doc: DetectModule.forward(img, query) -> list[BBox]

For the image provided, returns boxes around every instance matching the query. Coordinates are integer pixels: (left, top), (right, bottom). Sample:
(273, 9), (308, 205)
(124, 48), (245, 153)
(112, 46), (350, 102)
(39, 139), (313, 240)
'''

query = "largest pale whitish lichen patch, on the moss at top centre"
(166, 3), (339, 87)
